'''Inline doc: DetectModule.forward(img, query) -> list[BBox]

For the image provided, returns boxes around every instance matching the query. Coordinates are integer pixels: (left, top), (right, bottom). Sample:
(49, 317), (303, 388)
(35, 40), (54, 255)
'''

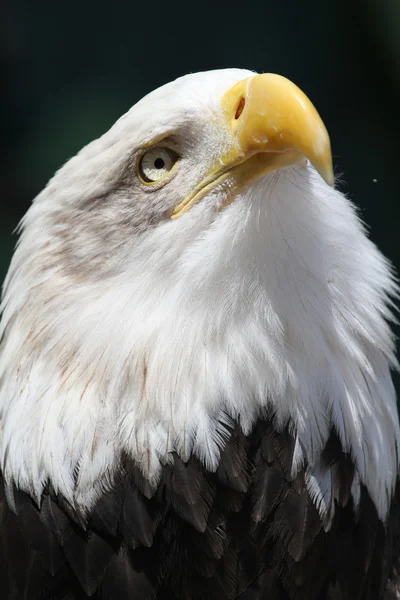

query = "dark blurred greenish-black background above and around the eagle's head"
(0, 0), (400, 360)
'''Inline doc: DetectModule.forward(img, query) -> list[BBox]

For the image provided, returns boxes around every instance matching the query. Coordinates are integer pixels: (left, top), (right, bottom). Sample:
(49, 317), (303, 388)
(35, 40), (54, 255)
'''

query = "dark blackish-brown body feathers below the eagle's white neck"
(0, 418), (399, 600)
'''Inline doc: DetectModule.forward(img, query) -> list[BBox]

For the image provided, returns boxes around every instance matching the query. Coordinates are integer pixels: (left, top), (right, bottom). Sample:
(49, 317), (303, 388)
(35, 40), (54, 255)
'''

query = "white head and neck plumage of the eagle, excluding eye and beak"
(0, 69), (399, 518)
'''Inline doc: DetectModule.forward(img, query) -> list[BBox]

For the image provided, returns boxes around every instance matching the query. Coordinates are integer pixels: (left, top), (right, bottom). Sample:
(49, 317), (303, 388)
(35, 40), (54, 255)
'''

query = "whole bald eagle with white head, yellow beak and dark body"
(0, 69), (400, 600)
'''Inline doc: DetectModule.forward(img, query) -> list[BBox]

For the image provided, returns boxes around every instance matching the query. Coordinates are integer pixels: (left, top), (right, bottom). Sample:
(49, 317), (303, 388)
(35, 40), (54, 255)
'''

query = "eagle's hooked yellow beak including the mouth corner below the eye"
(172, 73), (333, 218)
